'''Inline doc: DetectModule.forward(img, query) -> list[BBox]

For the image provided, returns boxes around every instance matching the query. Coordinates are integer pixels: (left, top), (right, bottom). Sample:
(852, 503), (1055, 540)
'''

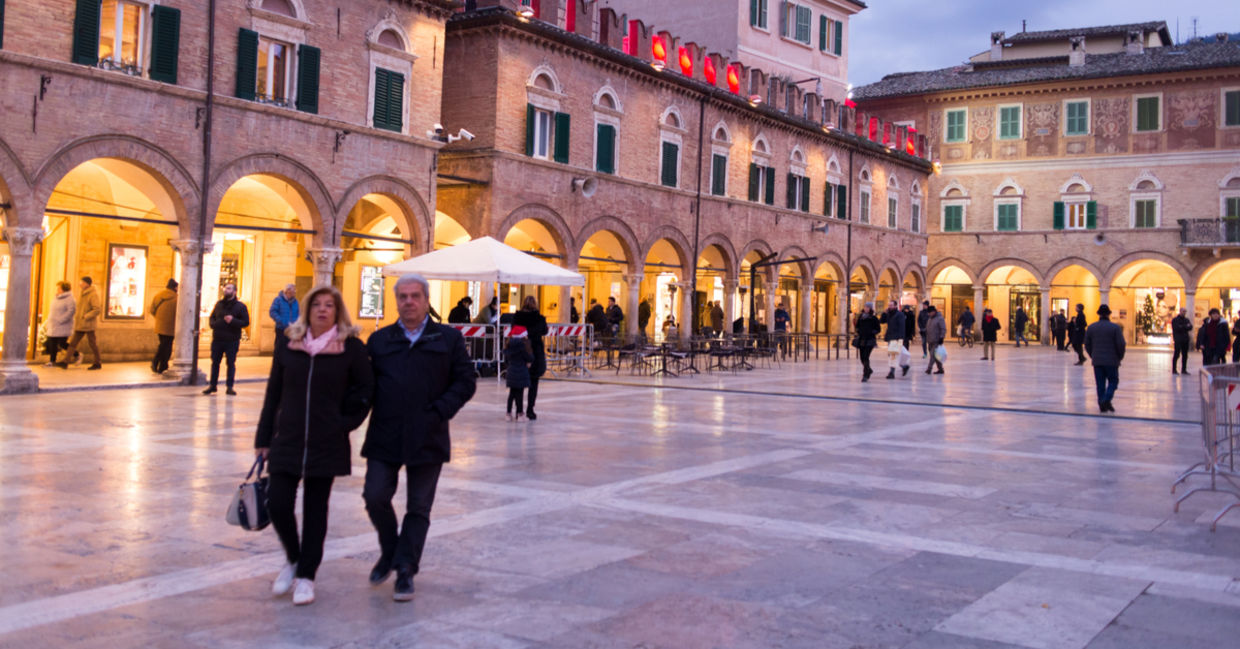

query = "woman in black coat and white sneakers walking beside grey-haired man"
(254, 287), (374, 606)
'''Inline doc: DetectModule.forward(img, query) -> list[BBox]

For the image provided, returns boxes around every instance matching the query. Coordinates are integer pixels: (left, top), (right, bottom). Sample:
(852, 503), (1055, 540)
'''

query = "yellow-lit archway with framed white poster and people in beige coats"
(35, 158), (183, 361)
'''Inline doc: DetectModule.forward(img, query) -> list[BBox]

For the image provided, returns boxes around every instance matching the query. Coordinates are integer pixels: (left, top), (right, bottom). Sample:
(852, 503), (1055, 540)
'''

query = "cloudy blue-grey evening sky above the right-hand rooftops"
(848, 0), (1240, 86)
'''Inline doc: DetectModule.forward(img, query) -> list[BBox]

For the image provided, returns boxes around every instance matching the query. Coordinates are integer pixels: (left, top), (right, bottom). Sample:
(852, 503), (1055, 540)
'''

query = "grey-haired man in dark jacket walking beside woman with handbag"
(362, 274), (476, 602)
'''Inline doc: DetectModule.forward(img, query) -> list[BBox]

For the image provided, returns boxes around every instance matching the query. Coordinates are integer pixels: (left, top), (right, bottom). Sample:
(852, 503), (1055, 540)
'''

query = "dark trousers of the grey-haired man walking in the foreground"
(362, 458), (444, 575)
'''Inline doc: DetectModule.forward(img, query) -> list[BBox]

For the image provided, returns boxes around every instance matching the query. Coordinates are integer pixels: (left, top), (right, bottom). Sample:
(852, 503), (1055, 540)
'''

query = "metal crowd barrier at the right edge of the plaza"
(1171, 364), (1240, 531)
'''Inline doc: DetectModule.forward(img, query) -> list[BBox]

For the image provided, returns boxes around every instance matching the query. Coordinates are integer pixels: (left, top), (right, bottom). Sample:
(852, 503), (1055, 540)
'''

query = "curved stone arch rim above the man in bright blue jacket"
(203, 153), (334, 247)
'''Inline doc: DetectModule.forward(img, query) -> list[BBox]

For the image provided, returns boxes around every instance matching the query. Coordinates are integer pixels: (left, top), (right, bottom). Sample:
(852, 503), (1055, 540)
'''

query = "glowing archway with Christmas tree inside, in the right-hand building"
(1111, 259), (1188, 345)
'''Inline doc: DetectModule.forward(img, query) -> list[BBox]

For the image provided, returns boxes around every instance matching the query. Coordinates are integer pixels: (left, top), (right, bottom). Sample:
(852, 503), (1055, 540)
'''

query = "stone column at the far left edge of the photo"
(0, 226), (43, 393)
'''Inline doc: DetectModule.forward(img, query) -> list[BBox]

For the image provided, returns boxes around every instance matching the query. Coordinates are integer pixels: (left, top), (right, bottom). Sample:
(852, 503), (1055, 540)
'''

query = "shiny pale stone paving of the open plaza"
(0, 347), (1240, 649)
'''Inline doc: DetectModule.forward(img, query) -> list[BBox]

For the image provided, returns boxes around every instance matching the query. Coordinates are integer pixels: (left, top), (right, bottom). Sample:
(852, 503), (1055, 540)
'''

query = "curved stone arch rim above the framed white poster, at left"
(31, 135), (200, 237)
